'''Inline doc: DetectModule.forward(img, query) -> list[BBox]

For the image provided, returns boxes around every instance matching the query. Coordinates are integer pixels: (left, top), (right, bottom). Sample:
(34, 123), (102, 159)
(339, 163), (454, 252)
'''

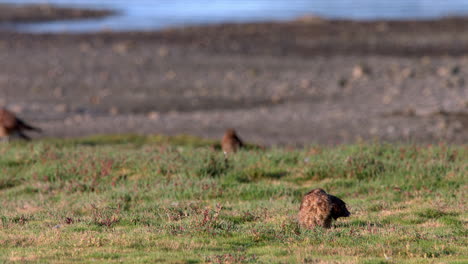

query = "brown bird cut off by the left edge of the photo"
(0, 108), (42, 141)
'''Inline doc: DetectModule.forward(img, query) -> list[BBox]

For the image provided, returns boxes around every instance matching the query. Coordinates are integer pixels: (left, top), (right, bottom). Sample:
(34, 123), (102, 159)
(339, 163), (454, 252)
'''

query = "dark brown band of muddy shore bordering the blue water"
(0, 17), (468, 57)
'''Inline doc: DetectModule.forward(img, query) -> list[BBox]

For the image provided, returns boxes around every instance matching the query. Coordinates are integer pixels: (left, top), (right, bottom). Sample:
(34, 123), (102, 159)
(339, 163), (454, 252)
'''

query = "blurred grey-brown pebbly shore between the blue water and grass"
(0, 15), (468, 146)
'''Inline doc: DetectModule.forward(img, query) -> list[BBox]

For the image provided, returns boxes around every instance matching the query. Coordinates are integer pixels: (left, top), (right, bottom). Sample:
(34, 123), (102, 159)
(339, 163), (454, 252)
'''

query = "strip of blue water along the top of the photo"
(0, 0), (468, 32)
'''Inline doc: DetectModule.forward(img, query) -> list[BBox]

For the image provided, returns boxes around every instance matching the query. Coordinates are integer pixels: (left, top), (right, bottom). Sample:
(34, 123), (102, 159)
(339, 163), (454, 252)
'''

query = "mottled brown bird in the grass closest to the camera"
(299, 189), (350, 229)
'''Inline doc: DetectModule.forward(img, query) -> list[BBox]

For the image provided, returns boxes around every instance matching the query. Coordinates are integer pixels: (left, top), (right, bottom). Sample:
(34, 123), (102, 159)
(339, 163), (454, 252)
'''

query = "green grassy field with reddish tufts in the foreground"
(0, 136), (468, 263)
